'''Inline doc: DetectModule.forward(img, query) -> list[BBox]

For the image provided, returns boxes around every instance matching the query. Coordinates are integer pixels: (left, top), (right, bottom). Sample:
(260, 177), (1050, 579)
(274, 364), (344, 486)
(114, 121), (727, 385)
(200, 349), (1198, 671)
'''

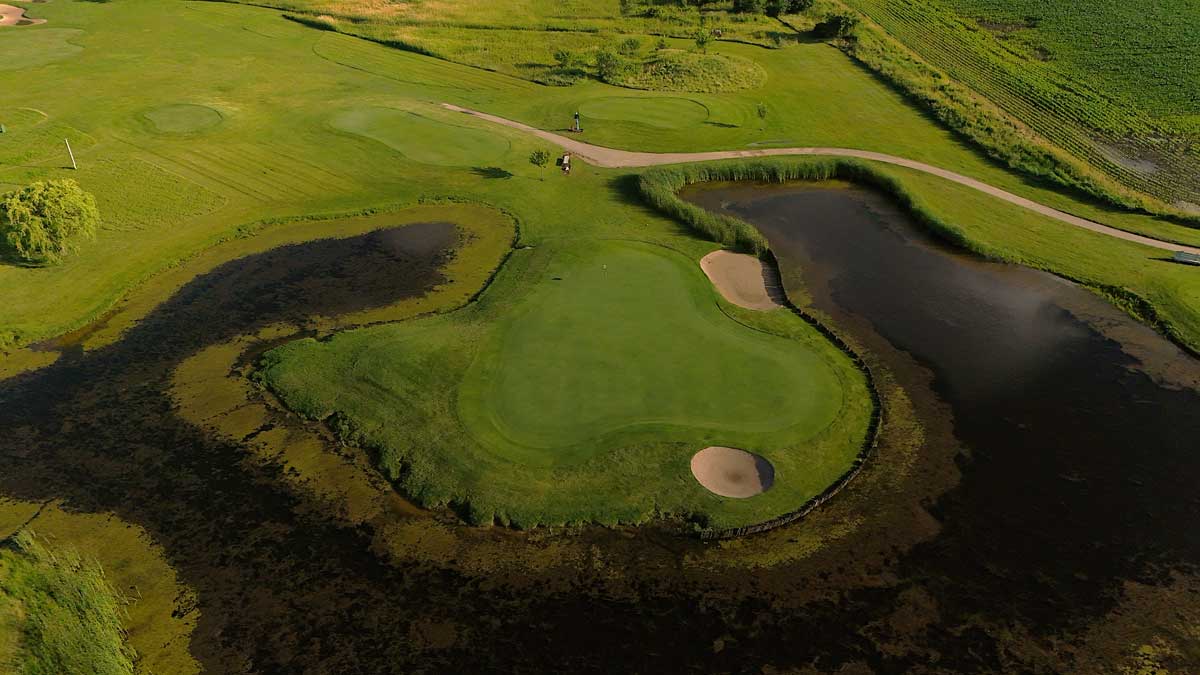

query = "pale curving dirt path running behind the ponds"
(442, 103), (1200, 255)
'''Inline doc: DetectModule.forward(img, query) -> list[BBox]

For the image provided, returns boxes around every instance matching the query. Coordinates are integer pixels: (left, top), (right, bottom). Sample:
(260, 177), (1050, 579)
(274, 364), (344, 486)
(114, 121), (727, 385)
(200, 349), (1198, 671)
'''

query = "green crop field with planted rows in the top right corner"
(847, 0), (1200, 205)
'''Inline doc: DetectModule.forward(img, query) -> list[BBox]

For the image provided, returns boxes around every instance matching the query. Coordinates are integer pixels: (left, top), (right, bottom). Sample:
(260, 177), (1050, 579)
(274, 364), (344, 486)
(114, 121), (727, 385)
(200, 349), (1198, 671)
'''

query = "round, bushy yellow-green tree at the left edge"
(0, 180), (100, 263)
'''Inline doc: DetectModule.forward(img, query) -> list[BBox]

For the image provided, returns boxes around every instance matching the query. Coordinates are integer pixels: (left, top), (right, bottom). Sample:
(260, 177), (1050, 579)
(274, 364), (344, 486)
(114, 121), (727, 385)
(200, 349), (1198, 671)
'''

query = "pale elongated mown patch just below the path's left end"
(330, 106), (509, 166)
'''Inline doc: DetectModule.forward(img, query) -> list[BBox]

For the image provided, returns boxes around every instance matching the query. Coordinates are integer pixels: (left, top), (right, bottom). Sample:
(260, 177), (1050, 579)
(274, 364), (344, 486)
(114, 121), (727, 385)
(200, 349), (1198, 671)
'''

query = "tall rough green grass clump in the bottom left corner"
(0, 531), (134, 675)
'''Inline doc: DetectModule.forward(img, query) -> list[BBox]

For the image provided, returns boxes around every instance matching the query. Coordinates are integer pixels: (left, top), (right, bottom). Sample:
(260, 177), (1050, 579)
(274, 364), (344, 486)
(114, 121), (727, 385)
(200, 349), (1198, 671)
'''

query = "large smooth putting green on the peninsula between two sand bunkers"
(458, 241), (841, 456)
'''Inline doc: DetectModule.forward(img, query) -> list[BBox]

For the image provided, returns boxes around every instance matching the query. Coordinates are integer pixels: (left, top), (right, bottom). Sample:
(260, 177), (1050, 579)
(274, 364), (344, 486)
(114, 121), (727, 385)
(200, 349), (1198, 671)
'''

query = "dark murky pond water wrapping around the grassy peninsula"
(0, 189), (1200, 673)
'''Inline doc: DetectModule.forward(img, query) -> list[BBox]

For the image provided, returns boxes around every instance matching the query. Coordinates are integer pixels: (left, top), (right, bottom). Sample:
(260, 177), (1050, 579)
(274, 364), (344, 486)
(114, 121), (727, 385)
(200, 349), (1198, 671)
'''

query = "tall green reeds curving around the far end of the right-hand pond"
(637, 157), (979, 257)
